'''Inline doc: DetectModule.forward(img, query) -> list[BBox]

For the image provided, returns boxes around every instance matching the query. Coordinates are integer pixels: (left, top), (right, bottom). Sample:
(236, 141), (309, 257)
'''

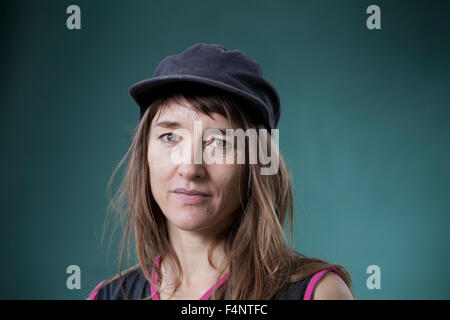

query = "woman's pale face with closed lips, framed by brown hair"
(147, 101), (246, 233)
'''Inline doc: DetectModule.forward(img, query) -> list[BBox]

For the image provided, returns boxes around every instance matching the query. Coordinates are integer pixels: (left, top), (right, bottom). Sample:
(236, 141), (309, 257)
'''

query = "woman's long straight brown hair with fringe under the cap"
(96, 84), (353, 300)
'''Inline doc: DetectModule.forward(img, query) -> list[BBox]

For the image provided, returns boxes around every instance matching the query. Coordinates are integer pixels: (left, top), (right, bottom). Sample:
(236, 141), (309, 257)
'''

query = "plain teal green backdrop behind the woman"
(0, 0), (450, 299)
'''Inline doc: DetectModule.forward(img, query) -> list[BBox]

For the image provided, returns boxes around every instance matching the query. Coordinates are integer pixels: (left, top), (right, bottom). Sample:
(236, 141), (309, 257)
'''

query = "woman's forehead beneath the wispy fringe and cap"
(151, 100), (233, 127)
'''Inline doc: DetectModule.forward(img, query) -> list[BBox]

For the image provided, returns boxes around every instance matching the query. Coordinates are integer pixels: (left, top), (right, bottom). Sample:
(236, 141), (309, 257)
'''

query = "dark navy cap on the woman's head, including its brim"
(129, 43), (280, 129)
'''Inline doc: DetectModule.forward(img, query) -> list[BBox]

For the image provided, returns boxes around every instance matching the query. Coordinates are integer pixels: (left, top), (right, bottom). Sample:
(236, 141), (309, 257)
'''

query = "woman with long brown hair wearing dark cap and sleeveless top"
(88, 44), (353, 299)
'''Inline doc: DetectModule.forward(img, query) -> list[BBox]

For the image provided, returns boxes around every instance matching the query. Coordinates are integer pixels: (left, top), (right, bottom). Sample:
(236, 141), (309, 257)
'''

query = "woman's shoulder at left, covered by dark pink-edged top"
(88, 267), (149, 300)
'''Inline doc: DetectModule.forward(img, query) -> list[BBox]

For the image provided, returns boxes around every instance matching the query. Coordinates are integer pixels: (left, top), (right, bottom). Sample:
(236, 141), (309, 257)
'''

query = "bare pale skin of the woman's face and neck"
(147, 101), (246, 299)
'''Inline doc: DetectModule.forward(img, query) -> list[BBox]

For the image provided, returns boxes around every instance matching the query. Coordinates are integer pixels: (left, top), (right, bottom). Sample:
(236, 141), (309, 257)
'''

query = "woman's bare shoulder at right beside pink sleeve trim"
(309, 270), (355, 300)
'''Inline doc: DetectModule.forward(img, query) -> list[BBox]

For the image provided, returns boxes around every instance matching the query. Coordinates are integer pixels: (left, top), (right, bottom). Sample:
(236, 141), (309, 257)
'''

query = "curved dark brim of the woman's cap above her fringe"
(129, 75), (274, 128)
